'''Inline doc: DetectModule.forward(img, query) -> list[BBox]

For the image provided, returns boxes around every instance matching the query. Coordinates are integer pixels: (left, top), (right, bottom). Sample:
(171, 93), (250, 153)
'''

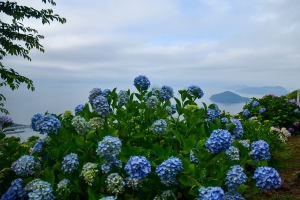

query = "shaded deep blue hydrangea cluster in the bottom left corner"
(1, 178), (27, 200)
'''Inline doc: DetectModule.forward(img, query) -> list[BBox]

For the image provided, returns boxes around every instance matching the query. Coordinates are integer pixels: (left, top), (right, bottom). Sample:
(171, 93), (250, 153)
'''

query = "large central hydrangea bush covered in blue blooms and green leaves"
(0, 76), (281, 200)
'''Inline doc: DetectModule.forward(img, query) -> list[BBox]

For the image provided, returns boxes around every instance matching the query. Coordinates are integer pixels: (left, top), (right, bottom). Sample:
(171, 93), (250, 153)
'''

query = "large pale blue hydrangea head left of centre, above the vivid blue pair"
(96, 136), (122, 158)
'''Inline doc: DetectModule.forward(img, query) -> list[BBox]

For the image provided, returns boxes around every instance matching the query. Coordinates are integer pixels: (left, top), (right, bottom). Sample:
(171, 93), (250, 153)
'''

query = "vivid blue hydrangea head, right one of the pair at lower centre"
(155, 156), (183, 186)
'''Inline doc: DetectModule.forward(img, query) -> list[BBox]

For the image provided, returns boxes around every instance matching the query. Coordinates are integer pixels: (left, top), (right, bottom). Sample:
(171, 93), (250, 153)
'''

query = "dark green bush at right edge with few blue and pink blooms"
(240, 94), (300, 134)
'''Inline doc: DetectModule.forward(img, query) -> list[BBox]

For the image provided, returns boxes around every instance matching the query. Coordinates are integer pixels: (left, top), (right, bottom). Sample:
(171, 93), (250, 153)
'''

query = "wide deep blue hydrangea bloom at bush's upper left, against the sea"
(31, 113), (61, 134)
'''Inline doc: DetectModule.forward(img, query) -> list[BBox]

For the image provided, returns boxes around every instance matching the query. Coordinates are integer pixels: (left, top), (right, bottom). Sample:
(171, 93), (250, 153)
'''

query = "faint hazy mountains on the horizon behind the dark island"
(235, 86), (289, 96)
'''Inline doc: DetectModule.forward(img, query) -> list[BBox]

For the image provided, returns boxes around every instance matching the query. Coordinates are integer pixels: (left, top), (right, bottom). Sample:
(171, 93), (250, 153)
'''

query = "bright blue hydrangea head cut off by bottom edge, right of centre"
(198, 186), (225, 200)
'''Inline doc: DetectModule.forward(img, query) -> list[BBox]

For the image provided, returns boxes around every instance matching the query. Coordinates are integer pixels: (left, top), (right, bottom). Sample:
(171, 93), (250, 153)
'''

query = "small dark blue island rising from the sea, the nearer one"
(209, 91), (250, 103)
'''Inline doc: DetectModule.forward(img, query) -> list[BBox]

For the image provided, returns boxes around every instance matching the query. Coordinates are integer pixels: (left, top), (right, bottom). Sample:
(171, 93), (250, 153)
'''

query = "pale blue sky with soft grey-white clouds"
(0, 0), (300, 123)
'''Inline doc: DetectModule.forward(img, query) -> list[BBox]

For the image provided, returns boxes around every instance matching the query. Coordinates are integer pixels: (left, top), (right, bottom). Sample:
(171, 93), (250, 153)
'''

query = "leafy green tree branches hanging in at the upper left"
(0, 0), (66, 114)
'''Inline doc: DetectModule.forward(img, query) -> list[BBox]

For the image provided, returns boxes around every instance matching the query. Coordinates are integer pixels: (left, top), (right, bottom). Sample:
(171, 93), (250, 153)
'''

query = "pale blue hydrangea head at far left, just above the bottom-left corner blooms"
(12, 155), (36, 177)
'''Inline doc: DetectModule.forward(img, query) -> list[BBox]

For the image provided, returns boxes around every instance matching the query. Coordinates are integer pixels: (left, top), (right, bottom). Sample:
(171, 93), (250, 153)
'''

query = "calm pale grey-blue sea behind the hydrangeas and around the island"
(4, 86), (262, 141)
